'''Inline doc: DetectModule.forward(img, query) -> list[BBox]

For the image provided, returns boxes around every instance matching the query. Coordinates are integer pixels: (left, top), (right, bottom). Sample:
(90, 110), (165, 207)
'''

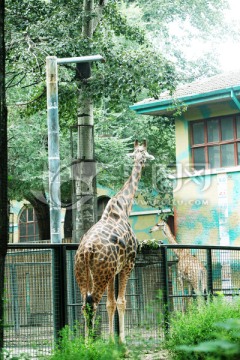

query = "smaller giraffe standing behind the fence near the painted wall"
(150, 220), (207, 294)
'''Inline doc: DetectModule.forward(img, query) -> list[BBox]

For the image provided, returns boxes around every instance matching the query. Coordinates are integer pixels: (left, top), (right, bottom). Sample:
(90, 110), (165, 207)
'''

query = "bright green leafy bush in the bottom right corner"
(164, 296), (240, 360)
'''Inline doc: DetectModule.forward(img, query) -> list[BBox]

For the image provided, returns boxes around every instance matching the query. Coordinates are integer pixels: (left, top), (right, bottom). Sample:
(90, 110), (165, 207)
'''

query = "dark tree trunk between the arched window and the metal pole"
(25, 193), (50, 240)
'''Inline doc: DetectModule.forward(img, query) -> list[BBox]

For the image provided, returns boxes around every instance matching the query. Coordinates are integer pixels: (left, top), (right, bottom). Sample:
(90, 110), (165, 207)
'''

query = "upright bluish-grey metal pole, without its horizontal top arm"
(46, 56), (62, 341)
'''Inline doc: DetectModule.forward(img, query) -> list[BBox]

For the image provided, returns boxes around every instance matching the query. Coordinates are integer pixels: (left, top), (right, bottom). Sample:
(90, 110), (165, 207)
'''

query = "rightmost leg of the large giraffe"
(117, 267), (132, 343)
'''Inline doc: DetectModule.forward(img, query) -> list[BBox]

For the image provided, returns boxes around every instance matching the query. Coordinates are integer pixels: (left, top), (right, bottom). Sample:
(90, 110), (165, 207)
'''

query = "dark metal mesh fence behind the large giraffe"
(4, 244), (240, 357)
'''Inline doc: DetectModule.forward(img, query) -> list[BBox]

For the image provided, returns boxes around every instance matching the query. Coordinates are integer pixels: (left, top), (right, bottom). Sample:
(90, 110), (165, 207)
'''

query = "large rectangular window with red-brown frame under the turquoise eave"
(190, 115), (240, 170)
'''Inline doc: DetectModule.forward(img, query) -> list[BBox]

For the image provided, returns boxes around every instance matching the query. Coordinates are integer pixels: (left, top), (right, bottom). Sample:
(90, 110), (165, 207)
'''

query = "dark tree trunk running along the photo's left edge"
(0, 0), (9, 359)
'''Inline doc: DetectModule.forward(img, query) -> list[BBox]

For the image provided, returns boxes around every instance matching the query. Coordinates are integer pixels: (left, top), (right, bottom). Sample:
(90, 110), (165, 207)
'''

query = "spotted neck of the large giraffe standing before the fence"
(115, 162), (142, 216)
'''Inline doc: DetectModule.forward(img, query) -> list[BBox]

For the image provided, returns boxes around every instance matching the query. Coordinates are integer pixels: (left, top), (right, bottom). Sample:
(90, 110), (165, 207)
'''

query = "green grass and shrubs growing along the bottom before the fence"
(6, 296), (240, 360)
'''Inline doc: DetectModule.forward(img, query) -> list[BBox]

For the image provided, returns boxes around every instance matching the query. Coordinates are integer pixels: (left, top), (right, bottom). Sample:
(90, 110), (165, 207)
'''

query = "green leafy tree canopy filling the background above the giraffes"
(6, 0), (236, 231)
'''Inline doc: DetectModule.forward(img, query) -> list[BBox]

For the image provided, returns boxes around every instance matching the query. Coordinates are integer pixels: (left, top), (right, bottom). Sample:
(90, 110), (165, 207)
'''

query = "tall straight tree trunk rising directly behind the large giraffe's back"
(73, 0), (96, 242)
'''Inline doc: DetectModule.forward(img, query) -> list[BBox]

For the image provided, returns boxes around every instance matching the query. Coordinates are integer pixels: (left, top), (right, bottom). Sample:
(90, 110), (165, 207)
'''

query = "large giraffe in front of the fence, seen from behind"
(75, 141), (154, 342)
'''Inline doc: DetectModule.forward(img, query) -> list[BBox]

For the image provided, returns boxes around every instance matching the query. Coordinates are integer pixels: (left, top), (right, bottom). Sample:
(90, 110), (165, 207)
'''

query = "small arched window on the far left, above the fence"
(18, 207), (39, 242)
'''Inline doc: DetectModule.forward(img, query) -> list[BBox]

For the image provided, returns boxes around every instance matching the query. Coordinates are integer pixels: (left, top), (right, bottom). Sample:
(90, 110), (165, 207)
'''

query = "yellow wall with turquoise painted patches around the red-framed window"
(174, 107), (240, 246)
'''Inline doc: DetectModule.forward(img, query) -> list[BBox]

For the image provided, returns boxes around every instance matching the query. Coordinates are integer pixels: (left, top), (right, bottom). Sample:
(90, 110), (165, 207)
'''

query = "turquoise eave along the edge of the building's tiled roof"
(130, 85), (240, 115)
